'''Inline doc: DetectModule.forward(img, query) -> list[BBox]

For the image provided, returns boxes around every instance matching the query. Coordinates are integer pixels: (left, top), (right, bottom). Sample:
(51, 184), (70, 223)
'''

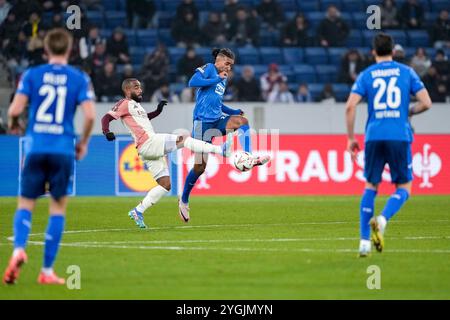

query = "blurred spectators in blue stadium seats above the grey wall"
(0, 0), (450, 107)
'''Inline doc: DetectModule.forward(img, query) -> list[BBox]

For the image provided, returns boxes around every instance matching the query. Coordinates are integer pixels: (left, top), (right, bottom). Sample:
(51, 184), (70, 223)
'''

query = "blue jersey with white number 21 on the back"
(17, 64), (94, 155)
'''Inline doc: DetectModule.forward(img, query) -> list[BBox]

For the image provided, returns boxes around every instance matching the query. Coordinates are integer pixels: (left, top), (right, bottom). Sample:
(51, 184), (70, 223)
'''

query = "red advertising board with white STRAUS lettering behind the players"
(179, 135), (450, 195)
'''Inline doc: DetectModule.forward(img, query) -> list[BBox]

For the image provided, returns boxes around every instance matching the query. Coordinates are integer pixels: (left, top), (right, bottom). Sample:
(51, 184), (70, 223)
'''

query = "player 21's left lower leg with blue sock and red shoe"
(3, 197), (36, 284)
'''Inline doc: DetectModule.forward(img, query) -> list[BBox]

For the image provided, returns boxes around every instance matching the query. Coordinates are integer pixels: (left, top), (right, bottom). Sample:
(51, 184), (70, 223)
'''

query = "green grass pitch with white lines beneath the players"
(0, 196), (450, 299)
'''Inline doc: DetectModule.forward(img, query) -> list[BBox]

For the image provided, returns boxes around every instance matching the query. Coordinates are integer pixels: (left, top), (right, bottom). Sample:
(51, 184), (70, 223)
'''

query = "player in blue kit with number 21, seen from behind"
(3, 29), (95, 285)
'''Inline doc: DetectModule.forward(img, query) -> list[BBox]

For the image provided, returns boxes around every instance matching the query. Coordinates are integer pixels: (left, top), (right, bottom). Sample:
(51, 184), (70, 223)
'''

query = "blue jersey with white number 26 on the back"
(352, 61), (424, 142)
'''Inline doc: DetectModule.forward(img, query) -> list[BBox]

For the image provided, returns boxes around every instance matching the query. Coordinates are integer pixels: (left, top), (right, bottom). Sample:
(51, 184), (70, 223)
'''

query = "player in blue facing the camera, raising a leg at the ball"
(179, 48), (270, 222)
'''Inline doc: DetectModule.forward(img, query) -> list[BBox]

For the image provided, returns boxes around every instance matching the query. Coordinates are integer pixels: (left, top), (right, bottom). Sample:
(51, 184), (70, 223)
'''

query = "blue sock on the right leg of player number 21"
(44, 215), (65, 268)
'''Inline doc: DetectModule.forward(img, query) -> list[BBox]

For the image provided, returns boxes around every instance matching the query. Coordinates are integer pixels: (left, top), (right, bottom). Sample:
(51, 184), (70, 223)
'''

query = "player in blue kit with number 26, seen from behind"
(346, 33), (431, 257)
